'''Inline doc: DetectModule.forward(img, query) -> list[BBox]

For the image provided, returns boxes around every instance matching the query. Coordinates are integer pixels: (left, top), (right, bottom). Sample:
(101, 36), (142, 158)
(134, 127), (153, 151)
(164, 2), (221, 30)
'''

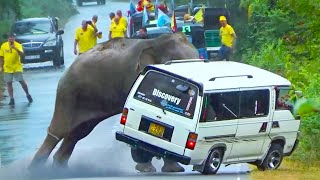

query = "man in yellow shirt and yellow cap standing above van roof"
(218, 16), (237, 61)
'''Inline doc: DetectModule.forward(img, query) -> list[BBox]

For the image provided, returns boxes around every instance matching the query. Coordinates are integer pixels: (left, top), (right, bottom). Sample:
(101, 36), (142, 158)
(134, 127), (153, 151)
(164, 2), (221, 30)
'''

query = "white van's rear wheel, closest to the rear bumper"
(202, 148), (223, 174)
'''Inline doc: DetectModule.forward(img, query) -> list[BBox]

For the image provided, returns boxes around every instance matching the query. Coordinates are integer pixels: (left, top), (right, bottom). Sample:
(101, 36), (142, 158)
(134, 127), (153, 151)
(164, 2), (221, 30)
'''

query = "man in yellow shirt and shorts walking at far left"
(0, 34), (33, 105)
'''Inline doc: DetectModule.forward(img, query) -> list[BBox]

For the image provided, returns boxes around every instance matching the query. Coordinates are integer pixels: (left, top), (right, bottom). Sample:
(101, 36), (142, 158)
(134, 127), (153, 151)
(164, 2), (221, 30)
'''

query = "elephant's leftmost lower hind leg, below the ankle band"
(29, 131), (60, 170)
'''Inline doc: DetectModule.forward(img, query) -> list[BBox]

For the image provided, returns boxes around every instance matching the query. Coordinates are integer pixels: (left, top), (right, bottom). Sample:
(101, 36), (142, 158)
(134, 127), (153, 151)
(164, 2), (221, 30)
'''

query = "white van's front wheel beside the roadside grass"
(257, 144), (283, 171)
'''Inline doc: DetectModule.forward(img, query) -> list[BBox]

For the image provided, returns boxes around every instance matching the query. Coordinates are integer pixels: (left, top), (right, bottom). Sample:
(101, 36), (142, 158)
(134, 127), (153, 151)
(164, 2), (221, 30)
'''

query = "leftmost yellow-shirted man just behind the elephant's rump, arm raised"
(73, 20), (98, 55)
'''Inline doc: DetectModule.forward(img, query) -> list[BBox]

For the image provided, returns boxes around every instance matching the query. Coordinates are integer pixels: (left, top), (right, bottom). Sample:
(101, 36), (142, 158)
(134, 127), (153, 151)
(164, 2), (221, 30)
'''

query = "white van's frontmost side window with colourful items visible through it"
(276, 87), (293, 112)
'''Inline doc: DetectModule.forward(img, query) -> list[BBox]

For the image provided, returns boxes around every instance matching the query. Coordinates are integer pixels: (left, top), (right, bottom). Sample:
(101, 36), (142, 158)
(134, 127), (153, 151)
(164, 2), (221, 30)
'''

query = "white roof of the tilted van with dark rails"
(151, 60), (291, 91)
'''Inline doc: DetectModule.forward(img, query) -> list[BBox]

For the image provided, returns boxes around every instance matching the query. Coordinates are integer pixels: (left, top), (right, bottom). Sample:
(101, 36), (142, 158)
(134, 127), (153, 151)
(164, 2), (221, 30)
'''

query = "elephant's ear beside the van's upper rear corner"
(136, 47), (157, 72)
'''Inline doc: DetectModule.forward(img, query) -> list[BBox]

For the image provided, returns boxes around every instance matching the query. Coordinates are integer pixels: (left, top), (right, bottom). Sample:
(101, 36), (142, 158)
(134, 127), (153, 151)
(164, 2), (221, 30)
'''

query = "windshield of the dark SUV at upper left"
(13, 21), (52, 35)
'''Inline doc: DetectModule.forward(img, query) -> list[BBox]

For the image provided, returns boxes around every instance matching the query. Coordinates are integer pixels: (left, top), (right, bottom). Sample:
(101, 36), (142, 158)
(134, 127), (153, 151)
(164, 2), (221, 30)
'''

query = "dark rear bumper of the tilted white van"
(116, 131), (191, 165)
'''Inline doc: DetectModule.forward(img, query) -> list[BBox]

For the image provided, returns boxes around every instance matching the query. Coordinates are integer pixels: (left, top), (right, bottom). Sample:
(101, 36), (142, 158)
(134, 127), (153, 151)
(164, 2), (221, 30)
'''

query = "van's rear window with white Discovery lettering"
(134, 71), (199, 119)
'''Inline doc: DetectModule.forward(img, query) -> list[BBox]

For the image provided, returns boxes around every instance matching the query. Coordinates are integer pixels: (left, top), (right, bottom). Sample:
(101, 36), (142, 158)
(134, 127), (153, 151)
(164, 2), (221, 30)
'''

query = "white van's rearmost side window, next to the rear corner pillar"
(200, 92), (239, 122)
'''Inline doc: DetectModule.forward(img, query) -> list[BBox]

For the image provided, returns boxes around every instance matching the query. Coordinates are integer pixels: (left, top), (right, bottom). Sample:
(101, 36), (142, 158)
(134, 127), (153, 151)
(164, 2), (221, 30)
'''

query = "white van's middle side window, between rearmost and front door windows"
(240, 89), (270, 118)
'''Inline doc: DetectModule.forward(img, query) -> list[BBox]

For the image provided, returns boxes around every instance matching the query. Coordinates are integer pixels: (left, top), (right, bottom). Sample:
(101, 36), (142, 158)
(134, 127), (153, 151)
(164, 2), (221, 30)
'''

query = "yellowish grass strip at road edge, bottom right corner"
(250, 158), (320, 180)
